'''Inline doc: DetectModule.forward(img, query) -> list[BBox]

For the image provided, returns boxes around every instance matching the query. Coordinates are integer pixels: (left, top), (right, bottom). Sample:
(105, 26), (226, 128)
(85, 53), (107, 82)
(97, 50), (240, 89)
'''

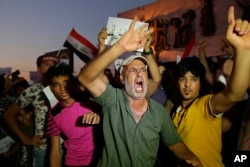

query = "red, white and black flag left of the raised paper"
(63, 28), (98, 63)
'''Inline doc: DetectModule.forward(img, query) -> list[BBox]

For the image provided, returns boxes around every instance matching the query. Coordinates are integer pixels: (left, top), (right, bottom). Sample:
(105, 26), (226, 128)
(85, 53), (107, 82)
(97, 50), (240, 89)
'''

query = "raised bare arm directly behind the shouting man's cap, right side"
(144, 35), (162, 96)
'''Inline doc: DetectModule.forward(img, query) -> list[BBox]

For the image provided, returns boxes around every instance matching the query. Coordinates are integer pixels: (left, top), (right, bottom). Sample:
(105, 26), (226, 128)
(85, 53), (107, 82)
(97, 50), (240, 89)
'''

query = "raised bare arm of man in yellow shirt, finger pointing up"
(210, 6), (250, 113)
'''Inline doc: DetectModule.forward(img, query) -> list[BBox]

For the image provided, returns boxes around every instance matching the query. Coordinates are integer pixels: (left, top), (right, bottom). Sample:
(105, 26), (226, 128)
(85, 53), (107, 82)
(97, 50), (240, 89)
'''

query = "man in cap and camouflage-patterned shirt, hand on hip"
(4, 55), (59, 167)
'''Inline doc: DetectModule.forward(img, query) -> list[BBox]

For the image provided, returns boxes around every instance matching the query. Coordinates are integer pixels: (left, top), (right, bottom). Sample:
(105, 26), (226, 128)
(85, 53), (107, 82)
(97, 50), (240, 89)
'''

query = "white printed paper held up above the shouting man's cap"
(105, 17), (148, 52)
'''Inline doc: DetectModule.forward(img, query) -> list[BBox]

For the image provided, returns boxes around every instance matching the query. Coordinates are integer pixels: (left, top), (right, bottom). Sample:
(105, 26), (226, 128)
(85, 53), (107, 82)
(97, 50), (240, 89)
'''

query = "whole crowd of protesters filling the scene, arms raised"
(0, 7), (250, 167)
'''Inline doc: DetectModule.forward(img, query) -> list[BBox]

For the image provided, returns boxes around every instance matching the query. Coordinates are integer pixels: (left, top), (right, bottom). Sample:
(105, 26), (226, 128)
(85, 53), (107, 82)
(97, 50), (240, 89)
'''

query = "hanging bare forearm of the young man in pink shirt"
(49, 136), (62, 167)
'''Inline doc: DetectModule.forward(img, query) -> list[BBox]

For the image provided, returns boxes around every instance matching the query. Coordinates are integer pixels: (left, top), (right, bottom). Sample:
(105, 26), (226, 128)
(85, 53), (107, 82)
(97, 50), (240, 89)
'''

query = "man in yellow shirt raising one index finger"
(169, 7), (250, 167)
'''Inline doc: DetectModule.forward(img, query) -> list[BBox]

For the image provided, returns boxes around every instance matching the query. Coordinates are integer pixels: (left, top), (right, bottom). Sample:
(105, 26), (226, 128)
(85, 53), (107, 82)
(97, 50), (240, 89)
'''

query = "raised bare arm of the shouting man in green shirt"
(78, 19), (153, 97)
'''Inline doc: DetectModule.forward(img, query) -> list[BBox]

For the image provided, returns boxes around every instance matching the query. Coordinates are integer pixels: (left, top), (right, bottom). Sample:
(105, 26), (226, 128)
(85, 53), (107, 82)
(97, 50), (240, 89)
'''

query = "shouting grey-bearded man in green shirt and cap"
(78, 17), (200, 167)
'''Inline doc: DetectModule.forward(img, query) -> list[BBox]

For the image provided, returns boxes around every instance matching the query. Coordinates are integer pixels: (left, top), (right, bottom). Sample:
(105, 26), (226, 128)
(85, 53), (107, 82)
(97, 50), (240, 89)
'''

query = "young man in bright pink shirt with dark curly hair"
(46, 63), (100, 167)
